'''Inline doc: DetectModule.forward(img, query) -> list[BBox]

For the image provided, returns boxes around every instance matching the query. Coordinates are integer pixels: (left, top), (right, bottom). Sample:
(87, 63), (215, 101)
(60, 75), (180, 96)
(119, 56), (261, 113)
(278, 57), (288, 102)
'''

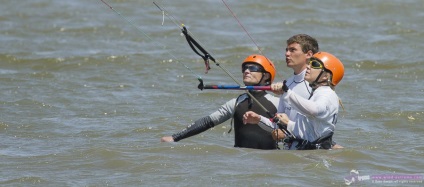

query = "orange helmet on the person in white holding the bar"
(312, 52), (344, 86)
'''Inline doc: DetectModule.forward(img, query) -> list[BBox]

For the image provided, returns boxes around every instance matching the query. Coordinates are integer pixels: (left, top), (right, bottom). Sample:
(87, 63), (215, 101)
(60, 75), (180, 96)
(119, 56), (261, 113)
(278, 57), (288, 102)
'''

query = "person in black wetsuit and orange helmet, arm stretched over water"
(161, 54), (279, 149)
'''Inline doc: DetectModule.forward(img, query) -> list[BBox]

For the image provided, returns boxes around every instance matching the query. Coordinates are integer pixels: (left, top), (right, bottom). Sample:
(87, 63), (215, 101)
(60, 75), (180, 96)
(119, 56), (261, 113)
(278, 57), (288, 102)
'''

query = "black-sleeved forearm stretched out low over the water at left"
(172, 116), (215, 142)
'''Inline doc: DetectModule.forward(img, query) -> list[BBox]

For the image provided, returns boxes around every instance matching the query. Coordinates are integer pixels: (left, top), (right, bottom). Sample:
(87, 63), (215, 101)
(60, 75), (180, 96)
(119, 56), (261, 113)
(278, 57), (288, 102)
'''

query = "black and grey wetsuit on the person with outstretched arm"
(172, 91), (279, 149)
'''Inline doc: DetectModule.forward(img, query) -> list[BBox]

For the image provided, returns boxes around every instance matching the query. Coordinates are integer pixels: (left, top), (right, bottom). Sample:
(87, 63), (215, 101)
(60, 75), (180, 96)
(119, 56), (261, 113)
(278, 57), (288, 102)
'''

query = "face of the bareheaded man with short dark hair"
(285, 43), (312, 74)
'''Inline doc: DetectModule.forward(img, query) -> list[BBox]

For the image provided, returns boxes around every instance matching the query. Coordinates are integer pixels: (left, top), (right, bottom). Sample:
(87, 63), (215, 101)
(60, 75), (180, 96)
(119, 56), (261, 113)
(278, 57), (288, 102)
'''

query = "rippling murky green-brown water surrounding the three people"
(0, 0), (424, 186)
